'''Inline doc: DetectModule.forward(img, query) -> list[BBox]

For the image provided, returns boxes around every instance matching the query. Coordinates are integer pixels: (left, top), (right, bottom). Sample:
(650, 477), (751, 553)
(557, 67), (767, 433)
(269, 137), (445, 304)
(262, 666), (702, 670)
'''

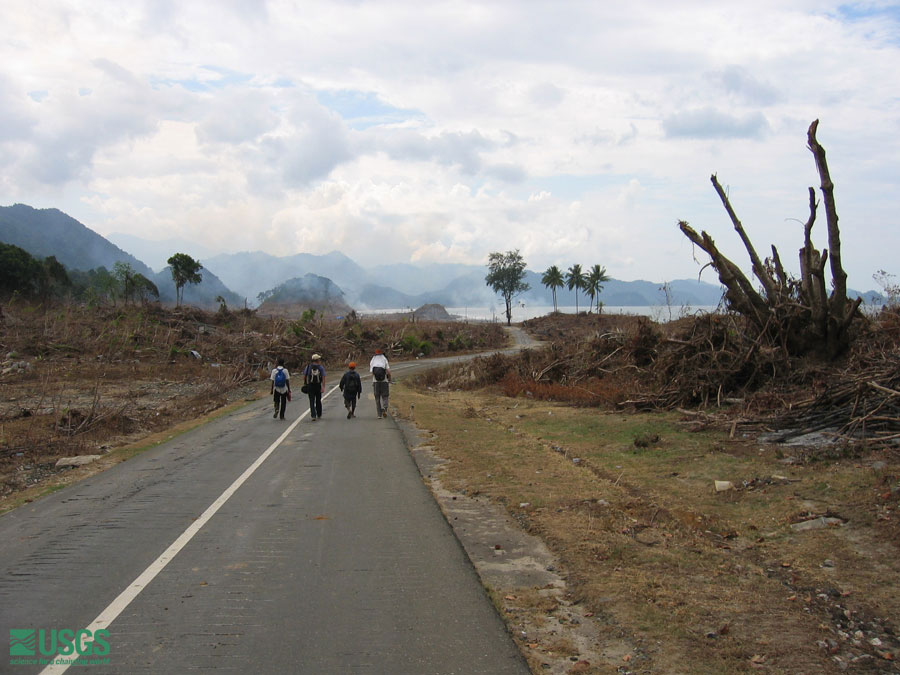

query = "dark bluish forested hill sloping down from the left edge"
(0, 204), (153, 278)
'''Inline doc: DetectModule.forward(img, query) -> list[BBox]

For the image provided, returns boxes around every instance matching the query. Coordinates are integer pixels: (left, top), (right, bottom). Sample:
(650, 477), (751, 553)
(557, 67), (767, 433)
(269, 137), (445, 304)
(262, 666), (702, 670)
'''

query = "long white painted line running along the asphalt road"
(41, 386), (337, 675)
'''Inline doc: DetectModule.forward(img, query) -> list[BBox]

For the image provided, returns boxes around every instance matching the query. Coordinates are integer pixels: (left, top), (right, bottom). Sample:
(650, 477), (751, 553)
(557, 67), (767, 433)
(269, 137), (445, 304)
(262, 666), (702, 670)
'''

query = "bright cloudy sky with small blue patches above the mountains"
(0, 0), (900, 290)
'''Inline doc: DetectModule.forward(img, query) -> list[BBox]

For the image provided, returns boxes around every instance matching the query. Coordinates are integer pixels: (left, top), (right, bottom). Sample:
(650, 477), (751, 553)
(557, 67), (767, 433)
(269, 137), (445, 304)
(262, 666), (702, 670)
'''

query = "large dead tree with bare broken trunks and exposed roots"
(678, 120), (862, 359)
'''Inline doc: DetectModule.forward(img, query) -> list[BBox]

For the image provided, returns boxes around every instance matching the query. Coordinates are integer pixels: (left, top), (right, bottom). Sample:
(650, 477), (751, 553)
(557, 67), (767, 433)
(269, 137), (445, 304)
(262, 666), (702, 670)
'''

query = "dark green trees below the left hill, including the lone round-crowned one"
(0, 242), (203, 305)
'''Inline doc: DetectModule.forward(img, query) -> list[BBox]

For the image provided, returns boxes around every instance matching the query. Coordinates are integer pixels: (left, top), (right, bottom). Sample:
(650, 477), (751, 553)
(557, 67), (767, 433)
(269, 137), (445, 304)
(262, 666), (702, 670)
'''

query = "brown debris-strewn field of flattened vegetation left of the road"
(0, 302), (506, 498)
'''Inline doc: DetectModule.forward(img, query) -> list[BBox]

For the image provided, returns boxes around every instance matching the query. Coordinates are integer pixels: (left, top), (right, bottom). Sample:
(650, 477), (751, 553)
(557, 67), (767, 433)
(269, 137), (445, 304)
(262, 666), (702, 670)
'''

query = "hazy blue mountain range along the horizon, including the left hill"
(0, 204), (760, 311)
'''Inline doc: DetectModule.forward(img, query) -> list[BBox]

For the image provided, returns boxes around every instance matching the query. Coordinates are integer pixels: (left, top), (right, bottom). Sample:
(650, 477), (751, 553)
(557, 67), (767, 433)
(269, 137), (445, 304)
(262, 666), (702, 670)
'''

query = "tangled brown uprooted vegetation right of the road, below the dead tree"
(418, 309), (900, 452)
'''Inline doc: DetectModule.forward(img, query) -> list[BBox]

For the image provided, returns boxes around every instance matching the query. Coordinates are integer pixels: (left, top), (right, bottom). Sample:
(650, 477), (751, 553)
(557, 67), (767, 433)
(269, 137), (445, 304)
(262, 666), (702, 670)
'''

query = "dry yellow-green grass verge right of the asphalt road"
(400, 383), (900, 673)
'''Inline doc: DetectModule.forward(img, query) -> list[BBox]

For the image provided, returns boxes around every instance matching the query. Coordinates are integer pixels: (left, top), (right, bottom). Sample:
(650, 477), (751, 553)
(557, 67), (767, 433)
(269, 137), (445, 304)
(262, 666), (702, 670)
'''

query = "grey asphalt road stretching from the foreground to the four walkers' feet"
(0, 330), (529, 674)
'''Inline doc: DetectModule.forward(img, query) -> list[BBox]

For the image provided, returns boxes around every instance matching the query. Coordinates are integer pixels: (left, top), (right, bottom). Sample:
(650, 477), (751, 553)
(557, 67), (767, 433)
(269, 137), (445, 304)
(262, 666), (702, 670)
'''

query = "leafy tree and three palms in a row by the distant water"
(484, 249), (609, 325)
